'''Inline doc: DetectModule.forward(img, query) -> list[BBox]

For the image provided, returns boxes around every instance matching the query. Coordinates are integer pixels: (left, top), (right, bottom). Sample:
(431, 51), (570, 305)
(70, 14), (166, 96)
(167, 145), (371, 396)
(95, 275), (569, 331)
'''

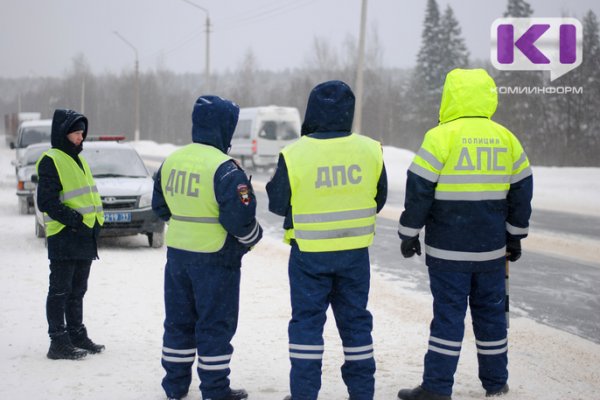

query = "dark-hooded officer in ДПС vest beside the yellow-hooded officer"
(267, 81), (387, 400)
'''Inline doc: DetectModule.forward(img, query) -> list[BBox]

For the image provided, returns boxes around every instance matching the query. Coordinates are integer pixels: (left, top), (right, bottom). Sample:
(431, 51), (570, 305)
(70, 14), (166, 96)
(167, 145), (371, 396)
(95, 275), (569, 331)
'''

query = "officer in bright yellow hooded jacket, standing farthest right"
(398, 69), (533, 400)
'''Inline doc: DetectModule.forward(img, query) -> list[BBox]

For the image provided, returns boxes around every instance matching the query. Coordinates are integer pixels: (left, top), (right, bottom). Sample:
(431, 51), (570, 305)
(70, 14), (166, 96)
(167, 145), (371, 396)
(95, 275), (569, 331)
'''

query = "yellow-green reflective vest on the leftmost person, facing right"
(36, 148), (104, 236)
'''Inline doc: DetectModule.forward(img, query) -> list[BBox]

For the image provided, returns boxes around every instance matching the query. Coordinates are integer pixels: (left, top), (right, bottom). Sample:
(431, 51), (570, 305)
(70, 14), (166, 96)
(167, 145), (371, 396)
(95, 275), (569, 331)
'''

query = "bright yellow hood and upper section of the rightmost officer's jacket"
(409, 69), (531, 201)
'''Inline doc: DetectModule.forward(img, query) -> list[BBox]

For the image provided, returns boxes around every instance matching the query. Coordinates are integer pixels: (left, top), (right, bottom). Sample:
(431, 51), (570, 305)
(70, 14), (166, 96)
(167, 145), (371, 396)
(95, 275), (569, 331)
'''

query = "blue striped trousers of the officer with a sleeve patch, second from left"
(162, 259), (240, 398)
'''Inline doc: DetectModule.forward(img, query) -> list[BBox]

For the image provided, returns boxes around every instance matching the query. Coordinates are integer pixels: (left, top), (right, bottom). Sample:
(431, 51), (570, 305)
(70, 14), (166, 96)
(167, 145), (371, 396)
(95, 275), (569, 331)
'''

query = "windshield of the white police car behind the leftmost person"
(82, 148), (148, 178)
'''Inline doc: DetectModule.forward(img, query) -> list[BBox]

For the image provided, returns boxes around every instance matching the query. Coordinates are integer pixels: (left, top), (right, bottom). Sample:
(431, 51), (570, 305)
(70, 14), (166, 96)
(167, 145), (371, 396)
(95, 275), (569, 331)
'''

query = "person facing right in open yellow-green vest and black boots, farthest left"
(37, 109), (104, 359)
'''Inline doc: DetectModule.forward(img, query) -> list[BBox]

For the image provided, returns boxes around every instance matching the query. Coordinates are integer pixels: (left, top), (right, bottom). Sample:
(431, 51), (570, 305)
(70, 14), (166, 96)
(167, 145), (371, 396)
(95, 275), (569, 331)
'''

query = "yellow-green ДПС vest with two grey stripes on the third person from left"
(281, 133), (383, 252)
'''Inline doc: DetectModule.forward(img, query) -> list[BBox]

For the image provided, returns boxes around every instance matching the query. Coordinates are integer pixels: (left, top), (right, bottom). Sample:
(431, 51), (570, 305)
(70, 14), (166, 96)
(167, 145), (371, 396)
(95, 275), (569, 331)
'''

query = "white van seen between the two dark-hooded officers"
(229, 106), (300, 168)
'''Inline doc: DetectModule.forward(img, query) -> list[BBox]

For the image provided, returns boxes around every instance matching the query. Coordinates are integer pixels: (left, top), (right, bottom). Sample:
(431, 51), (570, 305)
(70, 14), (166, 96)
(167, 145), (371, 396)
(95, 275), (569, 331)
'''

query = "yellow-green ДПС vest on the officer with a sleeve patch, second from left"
(160, 143), (231, 253)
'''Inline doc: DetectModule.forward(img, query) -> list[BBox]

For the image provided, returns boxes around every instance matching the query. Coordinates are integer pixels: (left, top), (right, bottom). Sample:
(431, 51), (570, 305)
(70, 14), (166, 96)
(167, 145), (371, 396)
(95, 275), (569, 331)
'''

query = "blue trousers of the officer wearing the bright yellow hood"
(422, 268), (508, 396)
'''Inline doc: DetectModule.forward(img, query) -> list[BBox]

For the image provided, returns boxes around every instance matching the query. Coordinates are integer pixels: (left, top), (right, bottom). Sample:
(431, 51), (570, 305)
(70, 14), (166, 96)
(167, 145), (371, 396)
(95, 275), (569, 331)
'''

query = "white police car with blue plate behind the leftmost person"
(35, 137), (165, 247)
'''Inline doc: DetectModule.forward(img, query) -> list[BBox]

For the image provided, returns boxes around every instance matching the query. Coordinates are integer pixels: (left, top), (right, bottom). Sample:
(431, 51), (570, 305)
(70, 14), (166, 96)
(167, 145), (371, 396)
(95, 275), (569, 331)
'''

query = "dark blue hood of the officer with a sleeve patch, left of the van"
(192, 96), (240, 153)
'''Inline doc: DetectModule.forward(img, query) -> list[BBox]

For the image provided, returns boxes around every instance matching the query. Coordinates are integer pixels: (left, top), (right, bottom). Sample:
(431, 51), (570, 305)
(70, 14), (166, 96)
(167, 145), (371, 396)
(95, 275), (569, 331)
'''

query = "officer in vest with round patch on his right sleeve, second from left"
(152, 96), (262, 400)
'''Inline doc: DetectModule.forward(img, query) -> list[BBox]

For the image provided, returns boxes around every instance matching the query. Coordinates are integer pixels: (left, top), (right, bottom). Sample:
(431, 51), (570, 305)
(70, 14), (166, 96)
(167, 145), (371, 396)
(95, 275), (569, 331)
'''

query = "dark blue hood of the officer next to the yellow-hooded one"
(302, 81), (354, 135)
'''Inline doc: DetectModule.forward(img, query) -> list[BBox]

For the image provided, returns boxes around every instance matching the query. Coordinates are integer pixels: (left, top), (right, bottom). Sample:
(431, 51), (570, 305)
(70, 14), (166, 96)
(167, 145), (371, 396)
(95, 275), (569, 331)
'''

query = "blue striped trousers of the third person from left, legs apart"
(288, 244), (375, 400)
